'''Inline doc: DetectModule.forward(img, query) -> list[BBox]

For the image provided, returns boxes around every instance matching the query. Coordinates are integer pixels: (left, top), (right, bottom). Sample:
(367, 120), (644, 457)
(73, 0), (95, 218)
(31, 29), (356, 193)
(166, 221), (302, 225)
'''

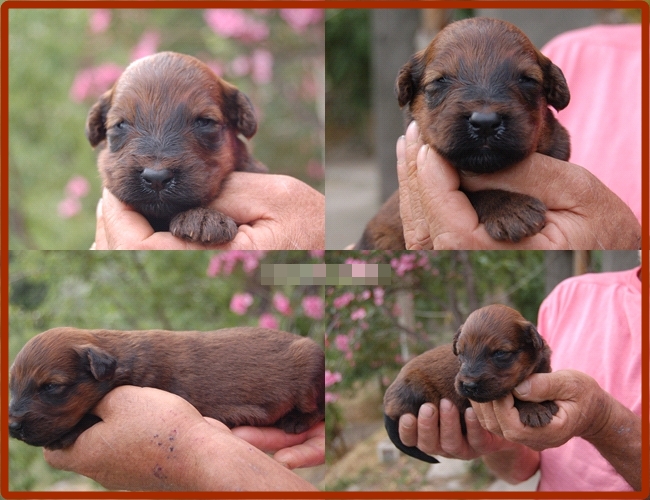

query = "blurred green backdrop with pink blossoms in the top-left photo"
(9, 9), (325, 250)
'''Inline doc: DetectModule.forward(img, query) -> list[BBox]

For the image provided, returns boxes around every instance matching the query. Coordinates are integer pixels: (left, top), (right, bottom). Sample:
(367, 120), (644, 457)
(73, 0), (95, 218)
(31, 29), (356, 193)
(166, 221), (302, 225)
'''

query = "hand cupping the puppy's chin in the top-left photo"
(93, 172), (325, 250)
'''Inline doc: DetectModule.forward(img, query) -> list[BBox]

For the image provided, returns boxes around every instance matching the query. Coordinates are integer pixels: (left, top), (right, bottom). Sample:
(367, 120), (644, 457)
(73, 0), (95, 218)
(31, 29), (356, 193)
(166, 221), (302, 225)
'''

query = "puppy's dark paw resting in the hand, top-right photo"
(465, 189), (546, 243)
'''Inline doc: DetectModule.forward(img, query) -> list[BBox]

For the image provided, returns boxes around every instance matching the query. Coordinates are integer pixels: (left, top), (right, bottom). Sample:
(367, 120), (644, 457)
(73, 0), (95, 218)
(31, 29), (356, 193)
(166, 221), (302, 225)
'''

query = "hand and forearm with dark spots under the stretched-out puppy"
(44, 386), (313, 491)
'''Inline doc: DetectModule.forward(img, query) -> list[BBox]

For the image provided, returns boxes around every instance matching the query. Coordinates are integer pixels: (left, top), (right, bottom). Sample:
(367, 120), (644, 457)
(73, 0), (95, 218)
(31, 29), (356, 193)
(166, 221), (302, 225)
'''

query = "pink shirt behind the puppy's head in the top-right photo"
(542, 24), (641, 221)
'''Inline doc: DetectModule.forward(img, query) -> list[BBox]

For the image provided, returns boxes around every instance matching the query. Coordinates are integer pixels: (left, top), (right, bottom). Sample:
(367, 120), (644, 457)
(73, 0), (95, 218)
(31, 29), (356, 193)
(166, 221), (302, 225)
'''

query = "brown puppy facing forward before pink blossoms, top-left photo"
(86, 52), (267, 244)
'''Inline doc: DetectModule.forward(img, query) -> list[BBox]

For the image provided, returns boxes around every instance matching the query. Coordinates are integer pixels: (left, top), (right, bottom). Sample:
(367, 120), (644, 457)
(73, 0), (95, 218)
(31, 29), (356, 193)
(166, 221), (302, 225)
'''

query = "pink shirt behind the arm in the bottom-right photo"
(538, 268), (641, 491)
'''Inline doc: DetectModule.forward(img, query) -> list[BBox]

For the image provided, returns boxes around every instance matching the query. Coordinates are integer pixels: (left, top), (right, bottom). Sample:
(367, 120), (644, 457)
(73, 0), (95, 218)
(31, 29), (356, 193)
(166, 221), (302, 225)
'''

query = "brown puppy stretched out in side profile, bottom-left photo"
(9, 328), (325, 449)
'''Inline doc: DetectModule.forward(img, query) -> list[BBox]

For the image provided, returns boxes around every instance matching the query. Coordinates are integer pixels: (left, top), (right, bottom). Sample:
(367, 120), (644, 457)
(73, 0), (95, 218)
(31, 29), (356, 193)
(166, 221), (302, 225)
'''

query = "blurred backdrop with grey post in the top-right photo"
(325, 9), (640, 250)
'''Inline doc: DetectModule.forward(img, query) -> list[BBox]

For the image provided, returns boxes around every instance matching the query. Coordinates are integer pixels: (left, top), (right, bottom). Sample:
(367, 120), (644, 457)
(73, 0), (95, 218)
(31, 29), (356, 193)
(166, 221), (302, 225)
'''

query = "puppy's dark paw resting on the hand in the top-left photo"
(169, 207), (237, 245)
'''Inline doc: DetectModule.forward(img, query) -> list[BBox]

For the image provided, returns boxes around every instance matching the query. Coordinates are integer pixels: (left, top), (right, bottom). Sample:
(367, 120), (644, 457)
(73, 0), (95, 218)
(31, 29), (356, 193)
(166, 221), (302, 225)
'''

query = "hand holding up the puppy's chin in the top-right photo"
(396, 122), (641, 250)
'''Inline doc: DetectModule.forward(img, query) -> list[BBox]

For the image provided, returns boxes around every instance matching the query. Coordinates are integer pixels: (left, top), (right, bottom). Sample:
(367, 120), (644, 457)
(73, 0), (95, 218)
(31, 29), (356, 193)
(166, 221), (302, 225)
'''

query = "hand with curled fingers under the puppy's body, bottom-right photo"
(399, 399), (516, 460)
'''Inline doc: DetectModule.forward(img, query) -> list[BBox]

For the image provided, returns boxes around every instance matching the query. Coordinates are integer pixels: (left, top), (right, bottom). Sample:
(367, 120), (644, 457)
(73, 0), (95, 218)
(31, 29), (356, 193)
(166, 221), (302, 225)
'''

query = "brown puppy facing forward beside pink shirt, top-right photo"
(357, 18), (569, 250)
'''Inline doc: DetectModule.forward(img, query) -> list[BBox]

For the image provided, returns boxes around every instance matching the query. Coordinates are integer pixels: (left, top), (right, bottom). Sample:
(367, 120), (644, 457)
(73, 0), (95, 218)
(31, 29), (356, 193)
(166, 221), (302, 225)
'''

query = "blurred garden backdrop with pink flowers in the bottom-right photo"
(320, 251), (639, 491)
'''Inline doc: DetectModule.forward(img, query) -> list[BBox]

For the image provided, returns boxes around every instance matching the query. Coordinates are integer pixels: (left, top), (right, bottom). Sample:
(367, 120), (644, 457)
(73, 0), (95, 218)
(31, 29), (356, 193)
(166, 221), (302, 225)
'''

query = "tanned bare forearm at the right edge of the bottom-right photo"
(582, 396), (641, 491)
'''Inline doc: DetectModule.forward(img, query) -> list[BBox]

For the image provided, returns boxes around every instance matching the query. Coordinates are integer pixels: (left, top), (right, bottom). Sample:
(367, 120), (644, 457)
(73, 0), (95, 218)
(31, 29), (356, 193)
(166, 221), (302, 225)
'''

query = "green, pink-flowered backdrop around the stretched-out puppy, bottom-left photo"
(9, 251), (324, 491)
